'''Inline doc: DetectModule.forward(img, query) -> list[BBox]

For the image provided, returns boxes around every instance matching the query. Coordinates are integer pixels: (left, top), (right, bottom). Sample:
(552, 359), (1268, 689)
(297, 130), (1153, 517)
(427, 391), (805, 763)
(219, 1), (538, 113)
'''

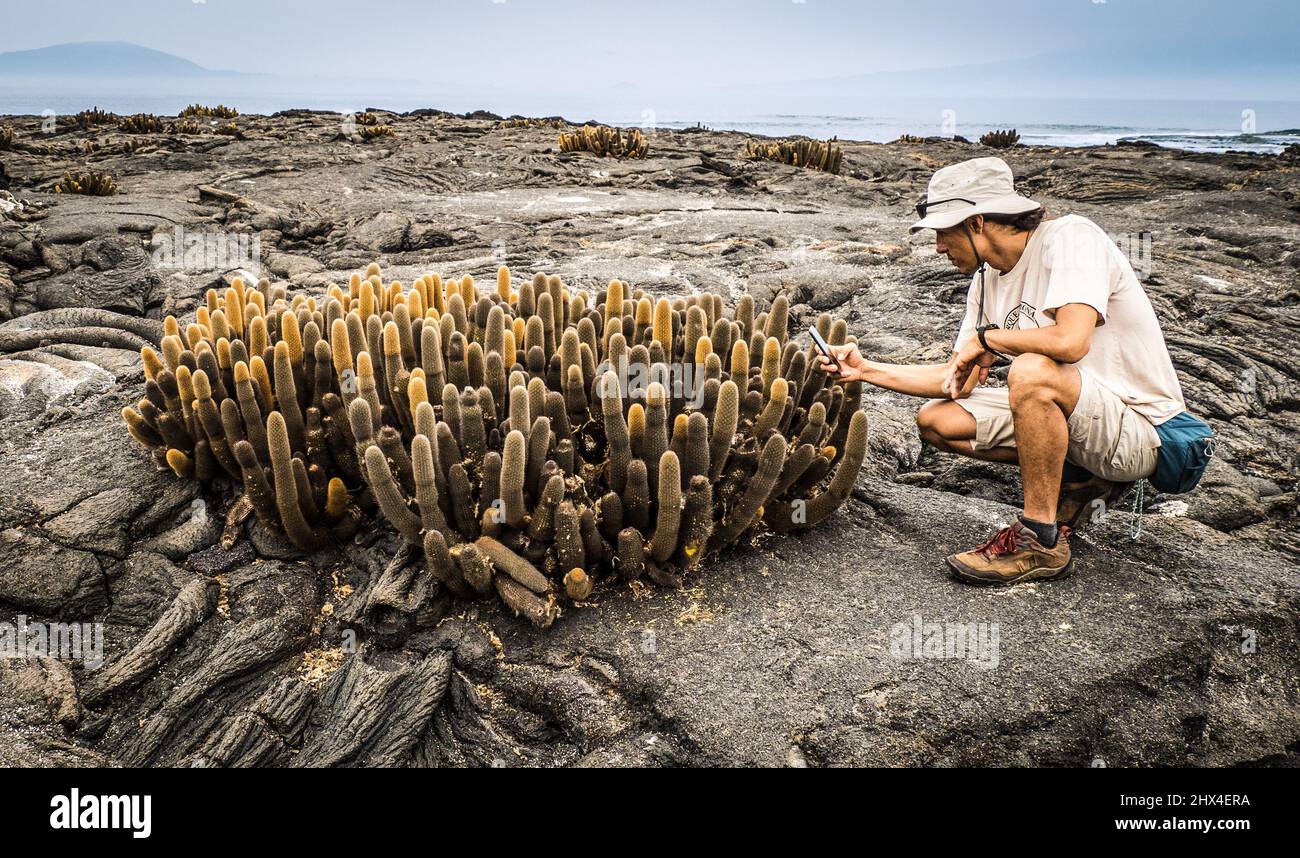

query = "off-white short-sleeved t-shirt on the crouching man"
(953, 215), (1187, 425)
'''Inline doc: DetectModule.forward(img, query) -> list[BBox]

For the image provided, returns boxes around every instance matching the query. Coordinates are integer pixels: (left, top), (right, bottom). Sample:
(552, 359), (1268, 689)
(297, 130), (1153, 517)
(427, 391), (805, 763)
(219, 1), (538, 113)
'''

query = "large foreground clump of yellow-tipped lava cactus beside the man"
(124, 264), (867, 627)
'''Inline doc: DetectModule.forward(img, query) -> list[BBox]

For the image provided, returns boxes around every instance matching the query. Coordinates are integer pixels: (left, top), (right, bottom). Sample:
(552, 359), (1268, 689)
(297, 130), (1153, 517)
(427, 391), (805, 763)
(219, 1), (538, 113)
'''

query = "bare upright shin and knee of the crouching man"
(1006, 354), (1080, 521)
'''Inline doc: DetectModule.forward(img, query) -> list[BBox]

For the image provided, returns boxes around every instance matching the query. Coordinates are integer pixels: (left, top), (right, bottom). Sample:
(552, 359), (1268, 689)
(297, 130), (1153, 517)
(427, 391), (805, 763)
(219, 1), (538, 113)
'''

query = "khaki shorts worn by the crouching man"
(936, 369), (1160, 482)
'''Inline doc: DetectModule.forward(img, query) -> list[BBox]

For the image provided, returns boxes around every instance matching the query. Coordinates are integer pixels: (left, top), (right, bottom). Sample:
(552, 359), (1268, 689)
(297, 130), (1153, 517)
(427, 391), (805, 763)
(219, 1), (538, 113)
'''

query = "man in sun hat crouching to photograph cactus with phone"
(822, 157), (1186, 584)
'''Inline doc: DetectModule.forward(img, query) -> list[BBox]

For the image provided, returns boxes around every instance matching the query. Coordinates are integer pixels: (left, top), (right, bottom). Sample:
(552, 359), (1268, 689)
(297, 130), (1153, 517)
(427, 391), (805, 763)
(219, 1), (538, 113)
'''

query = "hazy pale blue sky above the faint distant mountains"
(0, 0), (1300, 87)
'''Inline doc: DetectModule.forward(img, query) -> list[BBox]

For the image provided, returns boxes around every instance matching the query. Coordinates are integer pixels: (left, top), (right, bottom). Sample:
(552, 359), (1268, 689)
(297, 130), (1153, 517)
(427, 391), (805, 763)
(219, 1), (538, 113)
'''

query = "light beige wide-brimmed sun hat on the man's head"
(911, 157), (1041, 233)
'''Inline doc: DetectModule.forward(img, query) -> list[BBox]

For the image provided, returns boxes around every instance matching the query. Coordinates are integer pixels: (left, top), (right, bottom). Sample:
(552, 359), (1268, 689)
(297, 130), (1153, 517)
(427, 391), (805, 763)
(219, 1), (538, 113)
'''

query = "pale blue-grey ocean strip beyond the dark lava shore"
(0, 79), (1300, 153)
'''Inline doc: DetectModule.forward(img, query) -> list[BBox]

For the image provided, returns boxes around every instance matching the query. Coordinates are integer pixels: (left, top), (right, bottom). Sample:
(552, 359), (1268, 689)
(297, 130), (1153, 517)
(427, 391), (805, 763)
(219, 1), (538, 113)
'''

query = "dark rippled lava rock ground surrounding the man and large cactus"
(0, 111), (1300, 766)
